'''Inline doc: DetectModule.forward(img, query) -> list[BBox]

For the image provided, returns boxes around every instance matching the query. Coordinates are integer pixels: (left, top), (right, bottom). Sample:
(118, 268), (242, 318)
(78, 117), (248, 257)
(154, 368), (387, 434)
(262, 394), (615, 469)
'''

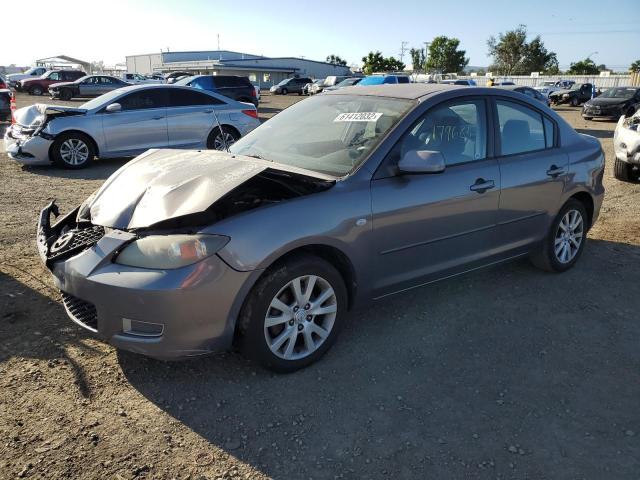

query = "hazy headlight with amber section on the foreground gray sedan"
(115, 235), (229, 269)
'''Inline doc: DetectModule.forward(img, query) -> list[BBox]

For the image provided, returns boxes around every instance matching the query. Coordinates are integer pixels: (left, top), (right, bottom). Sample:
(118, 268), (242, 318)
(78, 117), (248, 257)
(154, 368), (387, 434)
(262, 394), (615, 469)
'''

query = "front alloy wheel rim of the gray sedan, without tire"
(264, 275), (338, 360)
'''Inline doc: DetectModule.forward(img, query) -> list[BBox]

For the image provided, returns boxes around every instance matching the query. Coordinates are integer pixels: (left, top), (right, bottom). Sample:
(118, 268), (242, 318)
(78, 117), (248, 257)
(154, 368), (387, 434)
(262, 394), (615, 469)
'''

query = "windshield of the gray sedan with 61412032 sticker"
(229, 95), (414, 177)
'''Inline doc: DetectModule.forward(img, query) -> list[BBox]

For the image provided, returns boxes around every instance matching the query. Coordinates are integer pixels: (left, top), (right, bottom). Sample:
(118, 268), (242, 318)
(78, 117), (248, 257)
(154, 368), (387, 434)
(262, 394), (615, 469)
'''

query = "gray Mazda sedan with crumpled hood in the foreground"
(38, 84), (604, 371)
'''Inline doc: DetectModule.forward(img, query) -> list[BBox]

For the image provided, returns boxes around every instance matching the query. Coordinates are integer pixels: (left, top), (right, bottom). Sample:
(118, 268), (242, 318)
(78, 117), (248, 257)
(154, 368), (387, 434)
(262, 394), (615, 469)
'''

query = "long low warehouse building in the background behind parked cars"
(127, 50), (351, 88)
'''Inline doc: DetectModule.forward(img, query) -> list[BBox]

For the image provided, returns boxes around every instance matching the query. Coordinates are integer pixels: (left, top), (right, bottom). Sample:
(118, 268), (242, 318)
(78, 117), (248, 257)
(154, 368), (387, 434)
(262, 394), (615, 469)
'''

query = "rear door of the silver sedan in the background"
(167, 88), (225, 148)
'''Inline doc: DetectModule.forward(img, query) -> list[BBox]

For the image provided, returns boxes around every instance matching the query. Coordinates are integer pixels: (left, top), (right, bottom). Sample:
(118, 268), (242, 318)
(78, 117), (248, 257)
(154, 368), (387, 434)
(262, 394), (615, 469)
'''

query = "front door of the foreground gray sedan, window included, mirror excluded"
(371, 97), (500, 296)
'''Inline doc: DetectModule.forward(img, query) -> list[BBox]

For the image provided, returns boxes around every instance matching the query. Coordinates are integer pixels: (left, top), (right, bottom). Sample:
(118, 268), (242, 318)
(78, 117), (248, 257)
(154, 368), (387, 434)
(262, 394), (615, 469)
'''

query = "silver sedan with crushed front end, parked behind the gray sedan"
(4, 85), (260, 169)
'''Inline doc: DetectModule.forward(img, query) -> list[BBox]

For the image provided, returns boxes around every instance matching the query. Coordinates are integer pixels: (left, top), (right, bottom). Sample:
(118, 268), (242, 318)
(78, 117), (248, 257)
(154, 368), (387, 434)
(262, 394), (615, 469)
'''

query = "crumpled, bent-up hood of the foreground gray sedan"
(85, 150), (335, 229)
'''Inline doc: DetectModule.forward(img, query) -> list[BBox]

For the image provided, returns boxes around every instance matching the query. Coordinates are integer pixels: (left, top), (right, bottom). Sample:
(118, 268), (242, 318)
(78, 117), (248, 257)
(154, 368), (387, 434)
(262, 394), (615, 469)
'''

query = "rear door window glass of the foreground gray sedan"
(496, 100), (546, 155)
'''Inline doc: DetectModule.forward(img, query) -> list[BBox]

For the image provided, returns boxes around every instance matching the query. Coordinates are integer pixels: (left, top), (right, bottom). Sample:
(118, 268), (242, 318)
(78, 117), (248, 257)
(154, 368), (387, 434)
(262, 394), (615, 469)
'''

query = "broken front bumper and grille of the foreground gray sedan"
(38, 202), (256, 360)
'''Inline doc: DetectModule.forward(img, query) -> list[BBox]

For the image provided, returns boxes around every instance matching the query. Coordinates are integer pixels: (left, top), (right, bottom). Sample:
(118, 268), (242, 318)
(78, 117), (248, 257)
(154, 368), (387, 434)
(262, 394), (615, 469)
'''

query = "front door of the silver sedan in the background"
(100, 88), (168, 156)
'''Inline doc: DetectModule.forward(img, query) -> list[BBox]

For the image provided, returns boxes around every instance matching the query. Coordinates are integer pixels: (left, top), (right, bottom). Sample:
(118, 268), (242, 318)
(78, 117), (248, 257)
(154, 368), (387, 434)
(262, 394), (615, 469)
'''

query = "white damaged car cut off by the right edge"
(613, 110), (640, 182)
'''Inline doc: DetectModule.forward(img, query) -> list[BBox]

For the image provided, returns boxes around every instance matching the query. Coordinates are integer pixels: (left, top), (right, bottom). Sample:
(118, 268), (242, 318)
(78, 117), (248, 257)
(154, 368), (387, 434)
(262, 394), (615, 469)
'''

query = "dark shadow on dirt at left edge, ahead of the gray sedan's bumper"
(0, 270), (94, 398)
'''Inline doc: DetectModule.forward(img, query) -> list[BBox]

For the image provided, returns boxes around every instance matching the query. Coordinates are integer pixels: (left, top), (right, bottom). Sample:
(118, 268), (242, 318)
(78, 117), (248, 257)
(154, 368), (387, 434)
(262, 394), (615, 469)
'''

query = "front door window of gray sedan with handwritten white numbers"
(394, 99), (487, 166)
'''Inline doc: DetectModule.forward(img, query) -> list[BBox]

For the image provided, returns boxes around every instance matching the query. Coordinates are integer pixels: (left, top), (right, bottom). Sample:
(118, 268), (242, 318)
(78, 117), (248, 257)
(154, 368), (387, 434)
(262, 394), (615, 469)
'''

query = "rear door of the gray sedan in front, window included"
(495, 98), (569, 249)
